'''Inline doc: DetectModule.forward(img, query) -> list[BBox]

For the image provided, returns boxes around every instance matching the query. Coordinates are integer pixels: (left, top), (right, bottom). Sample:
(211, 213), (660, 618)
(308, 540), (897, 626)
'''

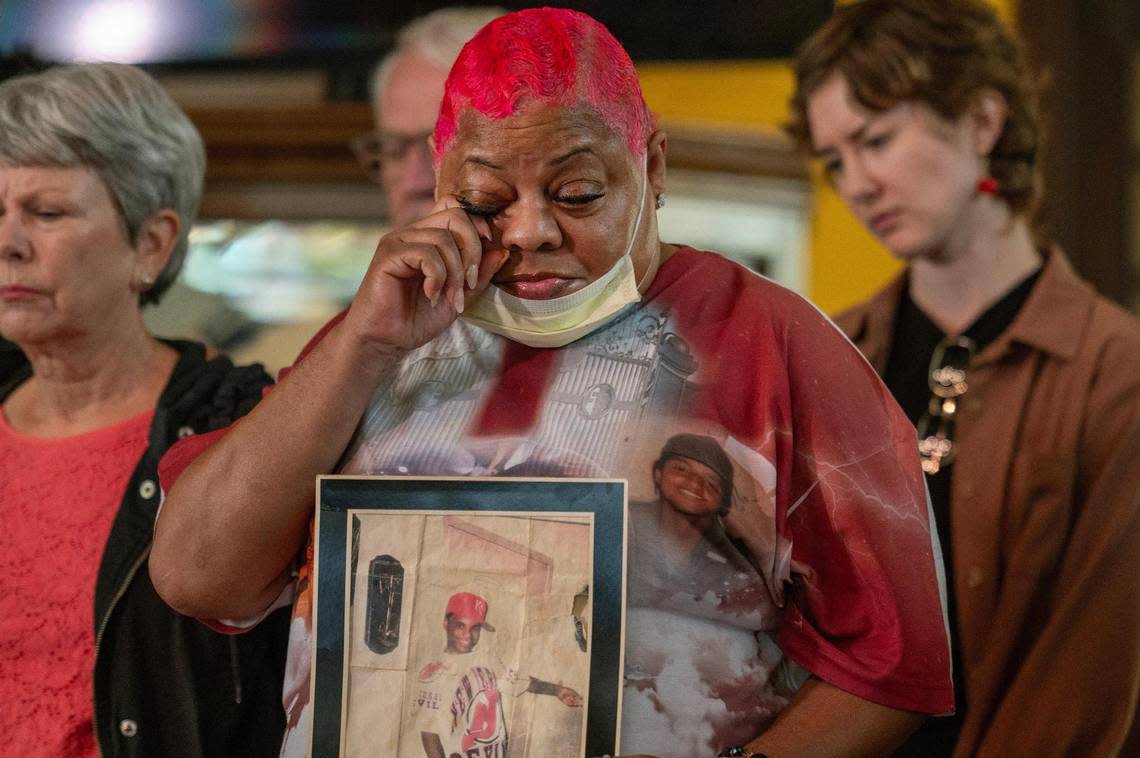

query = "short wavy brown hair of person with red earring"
(784, 0), (1041, 213)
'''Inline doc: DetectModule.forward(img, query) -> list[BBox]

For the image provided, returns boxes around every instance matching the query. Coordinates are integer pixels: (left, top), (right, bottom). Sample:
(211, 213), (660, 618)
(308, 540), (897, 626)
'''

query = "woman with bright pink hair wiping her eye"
(150, 8), (953, 758)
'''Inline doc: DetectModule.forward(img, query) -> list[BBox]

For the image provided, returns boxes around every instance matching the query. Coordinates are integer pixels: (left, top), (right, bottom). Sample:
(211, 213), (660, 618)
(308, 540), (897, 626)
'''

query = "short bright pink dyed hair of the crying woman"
(434, 8), (652, 163)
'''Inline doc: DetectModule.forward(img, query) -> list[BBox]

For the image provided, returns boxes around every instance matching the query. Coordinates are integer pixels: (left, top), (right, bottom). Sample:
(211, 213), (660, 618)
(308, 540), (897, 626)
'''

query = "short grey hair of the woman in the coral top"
(0, 63), (206, 304)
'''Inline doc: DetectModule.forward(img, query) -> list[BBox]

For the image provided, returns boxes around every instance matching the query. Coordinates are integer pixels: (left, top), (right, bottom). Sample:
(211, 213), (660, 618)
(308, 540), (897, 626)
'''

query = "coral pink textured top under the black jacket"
(0, 407), (154, 757)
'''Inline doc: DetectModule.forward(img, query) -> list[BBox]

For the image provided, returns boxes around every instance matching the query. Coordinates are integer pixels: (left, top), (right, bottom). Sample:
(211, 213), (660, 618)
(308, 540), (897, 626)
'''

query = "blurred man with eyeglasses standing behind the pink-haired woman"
(352, 7), (506, 228)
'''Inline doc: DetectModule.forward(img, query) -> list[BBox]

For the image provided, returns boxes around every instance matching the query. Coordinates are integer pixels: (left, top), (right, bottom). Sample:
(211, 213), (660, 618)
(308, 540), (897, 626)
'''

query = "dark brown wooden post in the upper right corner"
(1017, 0), (1140, 307)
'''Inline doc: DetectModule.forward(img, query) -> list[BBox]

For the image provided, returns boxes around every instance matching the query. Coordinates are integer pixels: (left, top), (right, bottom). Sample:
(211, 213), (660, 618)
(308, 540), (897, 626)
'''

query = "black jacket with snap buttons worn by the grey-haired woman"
(0, 341), (290, 758)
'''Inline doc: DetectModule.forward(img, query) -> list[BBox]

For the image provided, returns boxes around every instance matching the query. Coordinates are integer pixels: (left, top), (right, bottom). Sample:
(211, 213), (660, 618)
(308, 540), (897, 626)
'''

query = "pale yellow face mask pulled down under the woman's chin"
(459, 159), (649, 348)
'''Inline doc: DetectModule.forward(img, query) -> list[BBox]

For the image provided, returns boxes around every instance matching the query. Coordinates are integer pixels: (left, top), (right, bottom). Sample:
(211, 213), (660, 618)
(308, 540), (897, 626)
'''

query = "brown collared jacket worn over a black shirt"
(836, 250), (1140, 756)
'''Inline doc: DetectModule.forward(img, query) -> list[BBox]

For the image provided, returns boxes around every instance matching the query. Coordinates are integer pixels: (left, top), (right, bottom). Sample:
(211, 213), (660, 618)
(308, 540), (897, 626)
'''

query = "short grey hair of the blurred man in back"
(372, 6), (507, 104)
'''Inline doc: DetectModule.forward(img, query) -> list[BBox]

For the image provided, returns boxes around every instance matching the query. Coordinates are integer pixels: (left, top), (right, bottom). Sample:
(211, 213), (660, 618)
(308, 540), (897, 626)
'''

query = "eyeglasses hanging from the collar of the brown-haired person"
(918, 336), (977, 474)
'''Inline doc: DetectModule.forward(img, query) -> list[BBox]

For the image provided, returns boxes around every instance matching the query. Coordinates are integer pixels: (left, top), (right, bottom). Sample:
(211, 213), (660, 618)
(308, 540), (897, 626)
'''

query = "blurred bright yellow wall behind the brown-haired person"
(637, 0), (1016, 313)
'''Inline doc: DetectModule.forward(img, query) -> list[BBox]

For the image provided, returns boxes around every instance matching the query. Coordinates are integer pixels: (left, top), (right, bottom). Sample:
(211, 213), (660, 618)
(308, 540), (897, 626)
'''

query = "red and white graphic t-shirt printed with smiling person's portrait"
(164, 247), (953, 758)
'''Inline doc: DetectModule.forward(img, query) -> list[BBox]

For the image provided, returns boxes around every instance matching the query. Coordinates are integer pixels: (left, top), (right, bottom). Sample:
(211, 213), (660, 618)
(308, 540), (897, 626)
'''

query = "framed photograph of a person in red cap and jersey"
(310, 476), (627, 758)
